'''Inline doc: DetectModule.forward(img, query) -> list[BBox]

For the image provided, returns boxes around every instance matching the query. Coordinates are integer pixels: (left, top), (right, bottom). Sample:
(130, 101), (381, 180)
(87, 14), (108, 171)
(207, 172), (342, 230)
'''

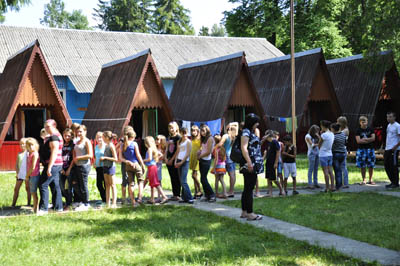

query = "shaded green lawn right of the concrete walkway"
(223, 193), (400, 251)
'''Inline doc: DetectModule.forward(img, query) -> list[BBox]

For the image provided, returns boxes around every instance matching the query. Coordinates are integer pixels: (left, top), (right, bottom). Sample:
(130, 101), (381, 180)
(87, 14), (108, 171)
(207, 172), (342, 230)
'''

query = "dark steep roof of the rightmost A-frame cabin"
(326, 51), (400, 130)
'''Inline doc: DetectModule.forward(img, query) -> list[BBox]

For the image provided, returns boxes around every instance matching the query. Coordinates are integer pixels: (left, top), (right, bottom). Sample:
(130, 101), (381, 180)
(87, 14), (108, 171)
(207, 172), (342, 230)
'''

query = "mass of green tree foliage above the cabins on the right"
(223, 0), (400, 63)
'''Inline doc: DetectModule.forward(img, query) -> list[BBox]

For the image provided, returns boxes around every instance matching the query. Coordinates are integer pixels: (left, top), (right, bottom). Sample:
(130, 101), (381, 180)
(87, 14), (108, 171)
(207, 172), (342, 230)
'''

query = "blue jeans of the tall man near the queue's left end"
(39, 165), (63, 211)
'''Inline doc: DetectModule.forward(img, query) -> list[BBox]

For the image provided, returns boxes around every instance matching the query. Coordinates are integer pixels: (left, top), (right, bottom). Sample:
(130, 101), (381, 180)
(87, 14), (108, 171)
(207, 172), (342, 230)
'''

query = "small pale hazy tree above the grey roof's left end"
(40, 0), (91, 30)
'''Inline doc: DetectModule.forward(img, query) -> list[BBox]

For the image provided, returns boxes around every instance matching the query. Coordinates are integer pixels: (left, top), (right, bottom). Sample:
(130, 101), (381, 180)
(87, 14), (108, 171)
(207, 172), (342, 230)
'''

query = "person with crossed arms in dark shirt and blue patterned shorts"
(356, 116), (376, 185)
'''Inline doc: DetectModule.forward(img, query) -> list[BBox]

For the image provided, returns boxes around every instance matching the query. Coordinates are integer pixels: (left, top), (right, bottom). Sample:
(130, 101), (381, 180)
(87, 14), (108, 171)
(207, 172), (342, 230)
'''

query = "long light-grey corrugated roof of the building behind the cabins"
(0, 25), (283, 93)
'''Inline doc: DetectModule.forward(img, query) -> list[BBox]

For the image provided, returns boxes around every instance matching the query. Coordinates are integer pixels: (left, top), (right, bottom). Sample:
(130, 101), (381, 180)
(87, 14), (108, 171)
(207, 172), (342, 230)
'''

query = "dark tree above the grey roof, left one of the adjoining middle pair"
(94, 0), (152, 32)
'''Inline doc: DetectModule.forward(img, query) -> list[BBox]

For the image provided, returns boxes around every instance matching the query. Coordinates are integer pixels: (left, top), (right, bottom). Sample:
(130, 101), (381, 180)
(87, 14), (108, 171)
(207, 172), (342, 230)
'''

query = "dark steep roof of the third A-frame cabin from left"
(169, 52), (264, 122)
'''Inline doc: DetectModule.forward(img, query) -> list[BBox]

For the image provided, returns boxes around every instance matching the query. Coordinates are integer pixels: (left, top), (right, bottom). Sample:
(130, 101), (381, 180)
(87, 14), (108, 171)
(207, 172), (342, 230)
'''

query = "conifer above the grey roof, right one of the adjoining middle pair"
(153, 0), (194, 35)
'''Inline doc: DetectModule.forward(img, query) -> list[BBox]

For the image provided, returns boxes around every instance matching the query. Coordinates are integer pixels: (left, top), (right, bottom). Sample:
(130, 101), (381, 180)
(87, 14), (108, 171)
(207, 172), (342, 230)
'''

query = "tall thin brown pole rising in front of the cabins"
(290, 0), (297, 146)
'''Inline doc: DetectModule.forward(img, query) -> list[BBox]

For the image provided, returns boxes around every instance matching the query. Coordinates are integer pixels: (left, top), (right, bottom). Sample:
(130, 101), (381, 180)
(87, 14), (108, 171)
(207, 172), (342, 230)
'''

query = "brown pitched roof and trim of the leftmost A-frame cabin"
(0, 40), (70, 146)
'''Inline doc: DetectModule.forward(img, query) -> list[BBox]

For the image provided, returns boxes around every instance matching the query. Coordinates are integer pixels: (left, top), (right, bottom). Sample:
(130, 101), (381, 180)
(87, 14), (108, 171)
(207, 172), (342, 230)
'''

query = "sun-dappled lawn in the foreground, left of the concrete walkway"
(0, 206), (369, 266)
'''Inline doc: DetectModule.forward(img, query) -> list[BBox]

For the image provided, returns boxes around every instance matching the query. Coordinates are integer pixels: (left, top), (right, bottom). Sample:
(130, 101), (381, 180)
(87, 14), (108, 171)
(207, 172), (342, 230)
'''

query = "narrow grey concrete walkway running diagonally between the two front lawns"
(193, 202), (400, 265)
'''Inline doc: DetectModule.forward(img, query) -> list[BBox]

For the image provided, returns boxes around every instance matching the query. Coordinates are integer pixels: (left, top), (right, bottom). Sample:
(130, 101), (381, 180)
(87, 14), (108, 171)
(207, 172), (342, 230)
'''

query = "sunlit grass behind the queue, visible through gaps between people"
(0, 155), (388, 207)
